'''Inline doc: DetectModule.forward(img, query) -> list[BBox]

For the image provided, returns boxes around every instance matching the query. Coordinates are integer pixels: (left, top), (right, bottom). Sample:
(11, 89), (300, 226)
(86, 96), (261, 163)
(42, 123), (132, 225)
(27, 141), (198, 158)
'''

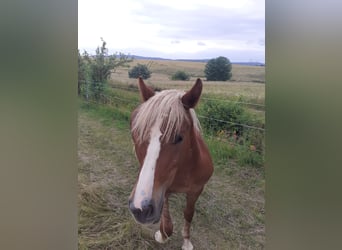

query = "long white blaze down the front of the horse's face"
(133, 122), (162, 210)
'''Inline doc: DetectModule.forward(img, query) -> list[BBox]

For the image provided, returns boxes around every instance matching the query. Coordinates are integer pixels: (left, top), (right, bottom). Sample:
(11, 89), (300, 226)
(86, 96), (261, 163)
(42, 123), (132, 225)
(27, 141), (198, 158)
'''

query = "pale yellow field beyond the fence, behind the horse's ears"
(111, 60), (265, 100)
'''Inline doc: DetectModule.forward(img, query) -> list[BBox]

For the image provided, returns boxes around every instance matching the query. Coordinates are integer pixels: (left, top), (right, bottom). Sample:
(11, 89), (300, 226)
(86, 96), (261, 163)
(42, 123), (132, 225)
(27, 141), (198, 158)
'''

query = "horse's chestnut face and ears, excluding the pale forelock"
(129, 79), (202, 224)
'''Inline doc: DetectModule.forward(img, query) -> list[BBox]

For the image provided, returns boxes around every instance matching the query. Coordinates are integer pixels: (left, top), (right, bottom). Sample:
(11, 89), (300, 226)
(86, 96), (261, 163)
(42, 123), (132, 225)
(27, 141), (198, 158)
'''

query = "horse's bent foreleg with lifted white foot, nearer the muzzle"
(154, 195), (173, 243)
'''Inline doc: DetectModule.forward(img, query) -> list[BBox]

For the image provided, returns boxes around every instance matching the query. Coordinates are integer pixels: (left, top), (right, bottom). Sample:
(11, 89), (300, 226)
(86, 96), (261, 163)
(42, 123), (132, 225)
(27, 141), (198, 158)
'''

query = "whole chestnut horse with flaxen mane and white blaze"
(129, 78), (213, 250)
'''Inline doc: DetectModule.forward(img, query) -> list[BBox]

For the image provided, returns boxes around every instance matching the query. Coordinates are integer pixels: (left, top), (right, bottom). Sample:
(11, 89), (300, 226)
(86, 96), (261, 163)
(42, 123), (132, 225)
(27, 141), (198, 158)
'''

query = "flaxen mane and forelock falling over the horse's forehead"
(132, 90), (200, 143)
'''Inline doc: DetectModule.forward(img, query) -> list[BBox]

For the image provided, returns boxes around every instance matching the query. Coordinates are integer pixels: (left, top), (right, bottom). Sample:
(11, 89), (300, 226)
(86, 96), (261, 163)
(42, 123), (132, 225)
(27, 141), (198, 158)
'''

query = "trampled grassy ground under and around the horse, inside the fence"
(79, 96), (265, 249)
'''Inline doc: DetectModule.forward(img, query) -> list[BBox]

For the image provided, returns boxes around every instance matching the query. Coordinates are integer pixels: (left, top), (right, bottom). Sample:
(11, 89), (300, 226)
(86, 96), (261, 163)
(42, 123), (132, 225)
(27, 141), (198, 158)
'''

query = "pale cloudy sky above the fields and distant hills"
(78, 0), (265, 62)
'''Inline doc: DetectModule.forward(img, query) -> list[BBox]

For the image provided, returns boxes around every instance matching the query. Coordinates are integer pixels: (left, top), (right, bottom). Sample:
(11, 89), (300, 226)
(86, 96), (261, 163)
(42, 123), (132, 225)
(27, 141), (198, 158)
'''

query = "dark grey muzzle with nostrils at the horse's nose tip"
(128, 200), (161, 224)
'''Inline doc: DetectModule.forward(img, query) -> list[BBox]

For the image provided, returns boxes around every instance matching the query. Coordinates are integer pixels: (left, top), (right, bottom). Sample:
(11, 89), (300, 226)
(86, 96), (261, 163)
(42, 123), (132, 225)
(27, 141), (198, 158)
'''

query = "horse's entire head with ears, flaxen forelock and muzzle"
(129, 78), (202, 224)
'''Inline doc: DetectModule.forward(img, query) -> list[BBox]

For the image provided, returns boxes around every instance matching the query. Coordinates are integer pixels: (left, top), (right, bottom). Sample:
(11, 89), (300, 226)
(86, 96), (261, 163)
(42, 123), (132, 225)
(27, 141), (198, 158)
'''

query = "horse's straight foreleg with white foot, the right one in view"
(182, 189), (203, 250)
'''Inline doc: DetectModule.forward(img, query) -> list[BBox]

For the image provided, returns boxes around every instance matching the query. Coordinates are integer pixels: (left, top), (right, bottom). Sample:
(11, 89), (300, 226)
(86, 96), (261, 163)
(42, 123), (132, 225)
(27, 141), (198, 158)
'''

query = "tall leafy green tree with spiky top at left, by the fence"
(79, 38), (133, 101)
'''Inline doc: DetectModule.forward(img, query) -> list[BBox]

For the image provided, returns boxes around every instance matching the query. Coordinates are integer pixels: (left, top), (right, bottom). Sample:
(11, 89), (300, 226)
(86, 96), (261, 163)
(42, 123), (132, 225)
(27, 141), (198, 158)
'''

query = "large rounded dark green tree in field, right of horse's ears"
(204, 56), (232, 81)
